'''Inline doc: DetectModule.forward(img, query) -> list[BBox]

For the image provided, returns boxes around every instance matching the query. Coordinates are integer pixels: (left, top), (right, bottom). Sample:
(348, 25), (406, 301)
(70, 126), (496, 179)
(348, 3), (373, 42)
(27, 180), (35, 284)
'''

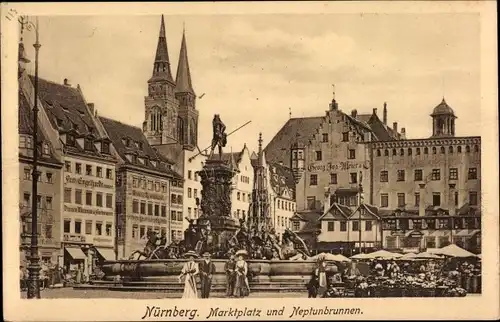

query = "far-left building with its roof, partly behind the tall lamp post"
(18, 88), (63, 265)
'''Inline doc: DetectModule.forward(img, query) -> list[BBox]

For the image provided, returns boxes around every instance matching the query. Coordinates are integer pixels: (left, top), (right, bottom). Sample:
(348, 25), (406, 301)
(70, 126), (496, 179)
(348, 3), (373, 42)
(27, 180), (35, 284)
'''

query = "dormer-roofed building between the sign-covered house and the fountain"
(99, 117), (184, 258)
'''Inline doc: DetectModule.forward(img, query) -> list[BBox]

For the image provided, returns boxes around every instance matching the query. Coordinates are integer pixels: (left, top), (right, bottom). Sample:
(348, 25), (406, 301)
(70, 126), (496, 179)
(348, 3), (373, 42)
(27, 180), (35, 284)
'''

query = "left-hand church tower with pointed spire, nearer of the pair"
(143, 15), (179, 145)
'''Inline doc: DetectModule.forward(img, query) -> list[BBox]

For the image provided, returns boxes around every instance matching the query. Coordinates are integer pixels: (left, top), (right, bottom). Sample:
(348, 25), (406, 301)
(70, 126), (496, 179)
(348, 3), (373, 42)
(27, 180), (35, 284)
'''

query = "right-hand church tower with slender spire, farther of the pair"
(175, 30), (199, 151)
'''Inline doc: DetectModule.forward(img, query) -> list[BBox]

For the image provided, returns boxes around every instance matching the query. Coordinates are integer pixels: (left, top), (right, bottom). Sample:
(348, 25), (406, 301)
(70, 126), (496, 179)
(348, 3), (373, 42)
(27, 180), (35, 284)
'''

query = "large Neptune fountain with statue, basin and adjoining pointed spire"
(85, 115), (315, 292)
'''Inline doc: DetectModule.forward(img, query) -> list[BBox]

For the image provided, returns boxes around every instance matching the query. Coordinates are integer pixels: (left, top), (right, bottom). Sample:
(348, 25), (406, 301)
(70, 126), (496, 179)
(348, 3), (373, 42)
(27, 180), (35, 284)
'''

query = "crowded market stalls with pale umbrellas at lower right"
(307, 244), (481, 297)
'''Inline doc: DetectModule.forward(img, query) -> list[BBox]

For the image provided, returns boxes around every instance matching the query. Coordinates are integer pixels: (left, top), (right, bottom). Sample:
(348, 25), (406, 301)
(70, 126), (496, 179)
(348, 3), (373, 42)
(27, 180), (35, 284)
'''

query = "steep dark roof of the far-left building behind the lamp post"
(18, 90), (60, 164)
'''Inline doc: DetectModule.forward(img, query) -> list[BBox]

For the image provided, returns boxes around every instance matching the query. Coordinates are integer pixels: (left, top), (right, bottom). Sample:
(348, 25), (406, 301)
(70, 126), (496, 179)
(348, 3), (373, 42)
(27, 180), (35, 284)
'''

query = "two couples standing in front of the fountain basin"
(179, 251), (250, 299)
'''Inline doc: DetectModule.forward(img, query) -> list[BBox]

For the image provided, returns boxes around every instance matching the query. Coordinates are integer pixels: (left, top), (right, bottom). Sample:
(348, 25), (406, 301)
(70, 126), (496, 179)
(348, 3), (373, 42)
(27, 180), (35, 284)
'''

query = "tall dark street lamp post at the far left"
(19, 17), (41, 299)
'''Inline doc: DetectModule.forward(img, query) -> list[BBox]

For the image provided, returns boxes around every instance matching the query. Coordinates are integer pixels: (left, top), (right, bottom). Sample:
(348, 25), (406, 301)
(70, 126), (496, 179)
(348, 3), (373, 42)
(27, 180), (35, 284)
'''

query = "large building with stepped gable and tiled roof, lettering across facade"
(265, 99), (405, 211)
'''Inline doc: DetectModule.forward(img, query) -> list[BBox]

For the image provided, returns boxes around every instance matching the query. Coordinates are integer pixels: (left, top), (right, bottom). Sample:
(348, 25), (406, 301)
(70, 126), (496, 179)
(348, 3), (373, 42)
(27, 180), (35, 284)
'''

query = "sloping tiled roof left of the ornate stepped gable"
(264, 116), (324, 165)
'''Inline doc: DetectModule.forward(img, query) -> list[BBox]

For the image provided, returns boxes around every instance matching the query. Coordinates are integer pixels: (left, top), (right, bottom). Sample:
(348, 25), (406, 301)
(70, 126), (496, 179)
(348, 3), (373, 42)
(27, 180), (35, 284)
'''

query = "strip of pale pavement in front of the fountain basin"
(21, 287), (307, 299)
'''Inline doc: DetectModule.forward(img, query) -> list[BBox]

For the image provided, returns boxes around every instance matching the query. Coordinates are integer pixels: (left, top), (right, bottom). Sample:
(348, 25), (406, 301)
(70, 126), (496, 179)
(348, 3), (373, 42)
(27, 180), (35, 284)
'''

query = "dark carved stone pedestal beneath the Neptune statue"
(198, 160), (239, 253)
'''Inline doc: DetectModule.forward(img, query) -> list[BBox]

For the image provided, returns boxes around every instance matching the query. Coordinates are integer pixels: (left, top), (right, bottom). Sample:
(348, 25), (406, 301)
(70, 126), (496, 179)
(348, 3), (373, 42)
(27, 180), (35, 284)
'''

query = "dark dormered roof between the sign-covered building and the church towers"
(99, 117), (180, 178)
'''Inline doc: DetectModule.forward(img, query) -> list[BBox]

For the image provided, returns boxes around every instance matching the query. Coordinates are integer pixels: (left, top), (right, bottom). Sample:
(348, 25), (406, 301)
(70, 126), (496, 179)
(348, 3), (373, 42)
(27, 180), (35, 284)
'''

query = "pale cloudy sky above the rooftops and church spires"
(24, 12), (481, 151)
